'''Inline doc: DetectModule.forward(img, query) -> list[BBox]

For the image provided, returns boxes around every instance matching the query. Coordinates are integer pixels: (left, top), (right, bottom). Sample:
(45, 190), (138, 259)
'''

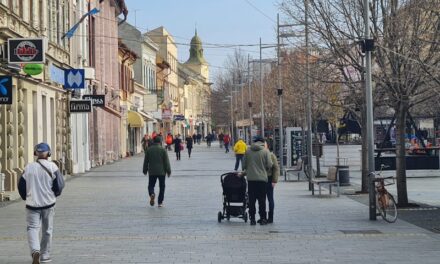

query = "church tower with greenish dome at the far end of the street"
(185, 29), (209, 82)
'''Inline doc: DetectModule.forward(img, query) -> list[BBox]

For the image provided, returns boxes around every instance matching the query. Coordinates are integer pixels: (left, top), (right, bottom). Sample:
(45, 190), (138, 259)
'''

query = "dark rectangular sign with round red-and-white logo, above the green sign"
(8, 38), (46, 64)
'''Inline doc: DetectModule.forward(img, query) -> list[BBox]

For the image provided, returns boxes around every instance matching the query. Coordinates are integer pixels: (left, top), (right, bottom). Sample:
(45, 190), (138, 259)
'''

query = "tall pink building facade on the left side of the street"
(89, 0), (128, 166)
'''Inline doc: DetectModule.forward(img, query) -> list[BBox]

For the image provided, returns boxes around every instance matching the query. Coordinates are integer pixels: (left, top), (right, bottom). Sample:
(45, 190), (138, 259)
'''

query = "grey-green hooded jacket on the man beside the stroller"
(243, 142), (273, 182)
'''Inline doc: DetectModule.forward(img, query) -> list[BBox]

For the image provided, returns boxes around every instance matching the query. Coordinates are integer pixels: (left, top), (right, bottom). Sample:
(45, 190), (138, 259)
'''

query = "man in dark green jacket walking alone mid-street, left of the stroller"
(143, 136), (171, 207)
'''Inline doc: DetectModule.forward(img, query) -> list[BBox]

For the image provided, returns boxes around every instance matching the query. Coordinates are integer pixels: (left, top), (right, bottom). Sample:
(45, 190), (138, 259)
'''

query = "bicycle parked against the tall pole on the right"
(373, 164), (397, 223)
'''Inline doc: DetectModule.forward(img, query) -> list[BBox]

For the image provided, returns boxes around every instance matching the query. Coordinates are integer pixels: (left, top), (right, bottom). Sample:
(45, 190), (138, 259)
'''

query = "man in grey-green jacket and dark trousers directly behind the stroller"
(241, 136), (273, 225)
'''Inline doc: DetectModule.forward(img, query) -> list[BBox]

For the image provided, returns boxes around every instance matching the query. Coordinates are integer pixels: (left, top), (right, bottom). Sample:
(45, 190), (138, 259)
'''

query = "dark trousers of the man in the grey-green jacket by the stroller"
(248, 181), (267, 220)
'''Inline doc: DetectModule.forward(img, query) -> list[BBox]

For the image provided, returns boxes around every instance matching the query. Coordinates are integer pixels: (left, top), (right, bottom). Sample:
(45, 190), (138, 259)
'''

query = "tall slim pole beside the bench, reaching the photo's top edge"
(304, 0), (313, 190)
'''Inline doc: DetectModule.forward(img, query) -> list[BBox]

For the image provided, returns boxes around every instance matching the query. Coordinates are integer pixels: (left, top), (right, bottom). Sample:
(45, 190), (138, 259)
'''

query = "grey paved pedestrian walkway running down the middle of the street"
(0, 146), (440, 264)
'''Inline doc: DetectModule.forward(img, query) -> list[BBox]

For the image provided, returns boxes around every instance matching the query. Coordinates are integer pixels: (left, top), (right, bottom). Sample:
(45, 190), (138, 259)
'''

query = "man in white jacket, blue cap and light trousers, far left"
(18, 143), (64, 264)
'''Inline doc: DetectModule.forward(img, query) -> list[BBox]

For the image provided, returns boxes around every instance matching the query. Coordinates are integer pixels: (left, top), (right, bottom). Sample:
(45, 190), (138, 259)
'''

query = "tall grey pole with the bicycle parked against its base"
(364, 0), (376, 220)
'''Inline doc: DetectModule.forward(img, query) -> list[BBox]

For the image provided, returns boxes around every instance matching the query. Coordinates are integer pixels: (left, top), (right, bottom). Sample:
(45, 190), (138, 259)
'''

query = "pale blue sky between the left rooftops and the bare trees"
(125, 0), (278, 79)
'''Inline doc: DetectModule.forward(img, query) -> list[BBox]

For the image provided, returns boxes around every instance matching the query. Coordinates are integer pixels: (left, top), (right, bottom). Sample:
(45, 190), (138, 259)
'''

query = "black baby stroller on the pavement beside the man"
(218, 172), (248, 223)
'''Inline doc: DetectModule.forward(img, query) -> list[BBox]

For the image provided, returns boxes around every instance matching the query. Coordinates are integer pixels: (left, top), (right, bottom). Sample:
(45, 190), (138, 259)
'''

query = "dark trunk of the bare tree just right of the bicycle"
(396, 102), (408, 207)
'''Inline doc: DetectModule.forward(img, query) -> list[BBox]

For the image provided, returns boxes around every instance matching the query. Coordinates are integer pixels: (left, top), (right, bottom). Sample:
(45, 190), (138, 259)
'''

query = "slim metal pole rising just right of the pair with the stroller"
(277, 14), (284, 171)
